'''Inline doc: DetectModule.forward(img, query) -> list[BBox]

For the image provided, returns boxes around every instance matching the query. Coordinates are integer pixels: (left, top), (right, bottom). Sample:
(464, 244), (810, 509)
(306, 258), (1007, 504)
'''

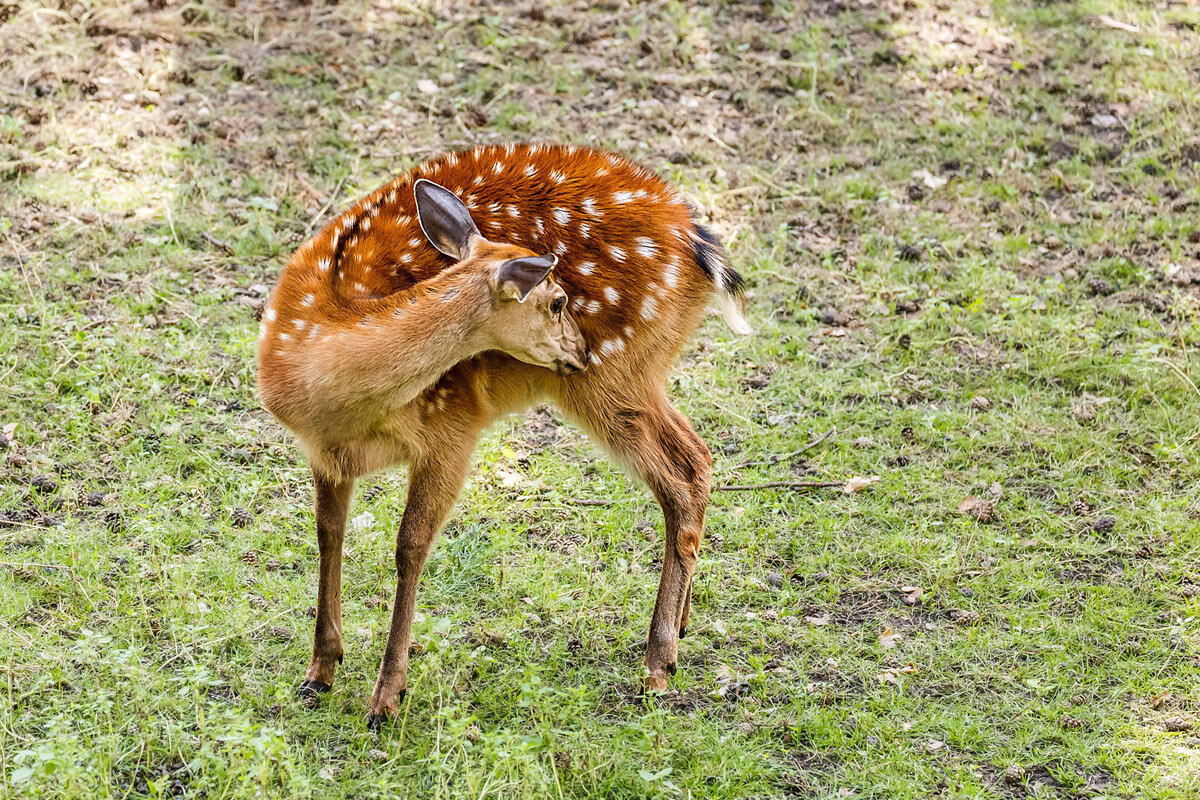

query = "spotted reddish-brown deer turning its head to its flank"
(258, 143), (750, 729)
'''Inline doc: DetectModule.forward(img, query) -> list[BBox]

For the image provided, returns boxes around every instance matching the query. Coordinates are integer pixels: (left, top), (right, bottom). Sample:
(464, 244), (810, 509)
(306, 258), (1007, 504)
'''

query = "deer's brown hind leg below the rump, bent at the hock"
(564, 392), (713, 691)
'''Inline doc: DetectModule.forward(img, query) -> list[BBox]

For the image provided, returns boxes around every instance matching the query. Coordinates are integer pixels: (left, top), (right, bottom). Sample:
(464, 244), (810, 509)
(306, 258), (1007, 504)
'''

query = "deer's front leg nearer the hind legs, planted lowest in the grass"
(367, 448), (474, 729)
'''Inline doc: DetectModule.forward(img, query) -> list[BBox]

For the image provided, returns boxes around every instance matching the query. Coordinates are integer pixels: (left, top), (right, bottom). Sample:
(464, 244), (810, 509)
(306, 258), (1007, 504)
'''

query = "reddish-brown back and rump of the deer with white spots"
(281, 144), (713, 374)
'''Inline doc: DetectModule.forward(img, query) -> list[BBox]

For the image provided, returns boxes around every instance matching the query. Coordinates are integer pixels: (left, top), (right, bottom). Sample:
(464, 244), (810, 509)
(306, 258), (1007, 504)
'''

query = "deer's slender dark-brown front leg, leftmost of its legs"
(296, 473), (354, 700)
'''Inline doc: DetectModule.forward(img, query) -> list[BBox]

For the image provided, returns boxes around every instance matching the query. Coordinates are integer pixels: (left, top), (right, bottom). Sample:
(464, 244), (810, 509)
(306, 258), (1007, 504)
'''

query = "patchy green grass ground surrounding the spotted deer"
(0, 0), (1200, 799)
